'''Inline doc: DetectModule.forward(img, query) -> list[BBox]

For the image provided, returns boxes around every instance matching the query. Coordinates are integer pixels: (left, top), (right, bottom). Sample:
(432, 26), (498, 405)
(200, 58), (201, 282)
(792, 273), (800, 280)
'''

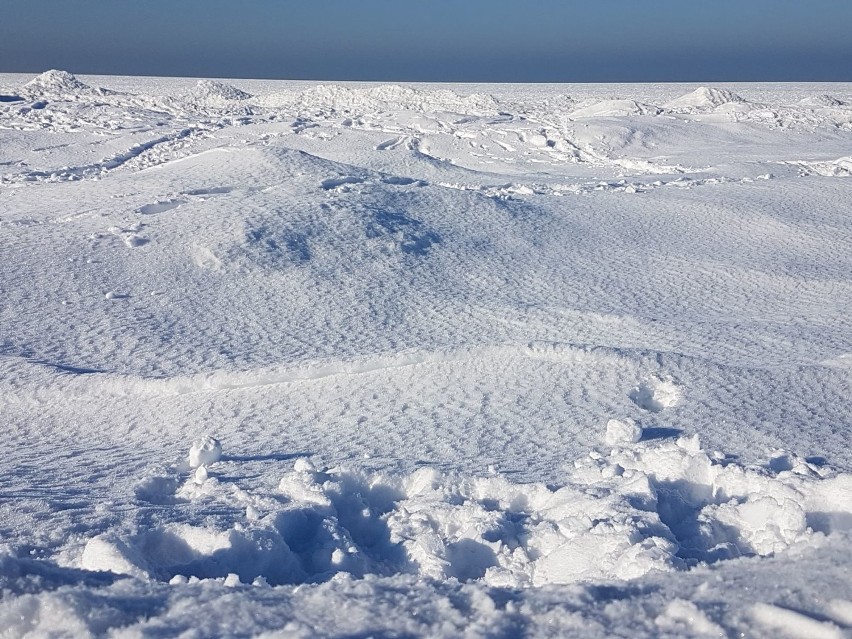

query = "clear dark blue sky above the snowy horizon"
(0, 0), (852, 82)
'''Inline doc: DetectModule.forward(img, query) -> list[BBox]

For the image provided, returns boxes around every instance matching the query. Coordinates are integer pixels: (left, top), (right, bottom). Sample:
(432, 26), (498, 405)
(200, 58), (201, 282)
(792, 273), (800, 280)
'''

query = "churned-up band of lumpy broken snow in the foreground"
(80, 432), (852, 587)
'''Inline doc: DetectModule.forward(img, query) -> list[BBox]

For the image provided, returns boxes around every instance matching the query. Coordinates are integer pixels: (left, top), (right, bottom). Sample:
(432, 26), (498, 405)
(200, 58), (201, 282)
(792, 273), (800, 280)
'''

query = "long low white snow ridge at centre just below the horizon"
(262, 84), (499, 115)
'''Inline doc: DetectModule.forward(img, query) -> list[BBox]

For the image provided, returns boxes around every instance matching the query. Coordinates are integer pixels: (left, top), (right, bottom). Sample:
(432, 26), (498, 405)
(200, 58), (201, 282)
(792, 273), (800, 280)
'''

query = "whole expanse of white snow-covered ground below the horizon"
(0, 72), (852, 639)
